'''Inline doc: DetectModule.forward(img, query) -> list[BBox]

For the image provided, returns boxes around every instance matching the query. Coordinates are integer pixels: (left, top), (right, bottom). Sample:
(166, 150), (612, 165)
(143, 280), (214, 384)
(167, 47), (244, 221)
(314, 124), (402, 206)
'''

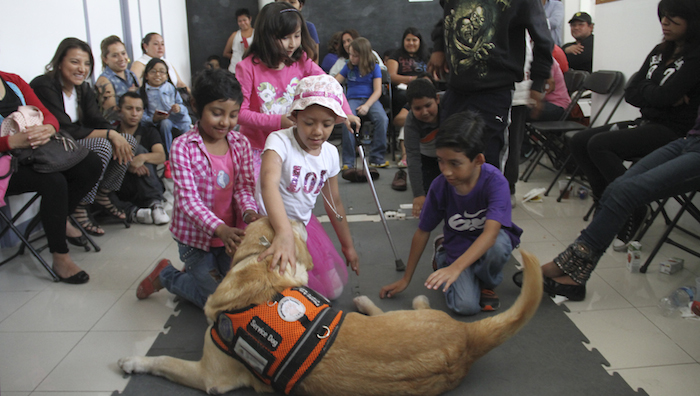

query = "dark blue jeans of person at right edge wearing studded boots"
(578, 135), (700, 253)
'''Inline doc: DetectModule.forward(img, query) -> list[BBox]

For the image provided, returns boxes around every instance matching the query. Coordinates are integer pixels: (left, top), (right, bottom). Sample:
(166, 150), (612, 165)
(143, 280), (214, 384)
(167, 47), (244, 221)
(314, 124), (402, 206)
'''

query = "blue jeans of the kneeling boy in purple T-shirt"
(435, 230), (513, 315)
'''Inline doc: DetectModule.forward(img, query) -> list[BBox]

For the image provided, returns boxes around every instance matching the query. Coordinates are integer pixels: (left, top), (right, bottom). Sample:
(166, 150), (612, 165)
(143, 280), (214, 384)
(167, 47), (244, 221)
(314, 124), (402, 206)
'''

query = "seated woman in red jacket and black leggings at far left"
(0, 72), (100, 284)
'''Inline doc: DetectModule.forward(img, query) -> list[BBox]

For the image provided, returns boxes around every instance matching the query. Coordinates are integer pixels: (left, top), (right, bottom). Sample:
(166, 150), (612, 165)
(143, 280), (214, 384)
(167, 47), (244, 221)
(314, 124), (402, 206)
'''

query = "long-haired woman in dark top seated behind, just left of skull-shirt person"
(386, 27), (430, 114)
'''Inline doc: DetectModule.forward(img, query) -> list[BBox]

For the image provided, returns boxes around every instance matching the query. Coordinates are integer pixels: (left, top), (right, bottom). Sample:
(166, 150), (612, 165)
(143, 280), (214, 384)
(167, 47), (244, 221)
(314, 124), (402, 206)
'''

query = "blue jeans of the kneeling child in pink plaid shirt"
(160, 242), (231, 308)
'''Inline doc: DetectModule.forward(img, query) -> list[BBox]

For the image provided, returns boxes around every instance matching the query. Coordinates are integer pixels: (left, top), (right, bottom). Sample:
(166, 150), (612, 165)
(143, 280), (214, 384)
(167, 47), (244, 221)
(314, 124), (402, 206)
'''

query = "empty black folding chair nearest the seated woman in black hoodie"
(532, 70), (624, 202)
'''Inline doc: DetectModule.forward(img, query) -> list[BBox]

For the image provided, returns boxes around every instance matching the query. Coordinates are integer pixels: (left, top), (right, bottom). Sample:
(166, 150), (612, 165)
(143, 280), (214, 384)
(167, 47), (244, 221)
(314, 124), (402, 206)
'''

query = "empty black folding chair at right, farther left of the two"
(520, 69), (589, 182)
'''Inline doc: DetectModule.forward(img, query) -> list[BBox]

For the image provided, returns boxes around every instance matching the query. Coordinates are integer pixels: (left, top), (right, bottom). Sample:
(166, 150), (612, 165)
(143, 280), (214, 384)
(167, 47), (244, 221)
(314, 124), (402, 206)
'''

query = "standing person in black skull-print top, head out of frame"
(428, 0), (552, 169)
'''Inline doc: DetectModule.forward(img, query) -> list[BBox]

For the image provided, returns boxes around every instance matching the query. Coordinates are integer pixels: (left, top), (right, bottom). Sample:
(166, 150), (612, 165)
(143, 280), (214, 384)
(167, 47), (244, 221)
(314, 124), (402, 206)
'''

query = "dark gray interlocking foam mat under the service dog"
(114, 217), (646, 396)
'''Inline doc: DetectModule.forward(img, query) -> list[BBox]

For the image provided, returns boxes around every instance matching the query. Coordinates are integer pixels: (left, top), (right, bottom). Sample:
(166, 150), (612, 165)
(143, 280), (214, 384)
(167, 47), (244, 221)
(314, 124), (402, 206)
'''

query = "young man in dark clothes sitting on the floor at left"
(117, 92), (170, 225)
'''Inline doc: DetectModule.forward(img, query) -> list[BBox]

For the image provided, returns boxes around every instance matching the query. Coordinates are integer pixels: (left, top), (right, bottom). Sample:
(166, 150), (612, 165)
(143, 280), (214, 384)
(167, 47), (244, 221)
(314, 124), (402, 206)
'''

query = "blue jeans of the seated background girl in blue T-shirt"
(343, 98), (389, 168)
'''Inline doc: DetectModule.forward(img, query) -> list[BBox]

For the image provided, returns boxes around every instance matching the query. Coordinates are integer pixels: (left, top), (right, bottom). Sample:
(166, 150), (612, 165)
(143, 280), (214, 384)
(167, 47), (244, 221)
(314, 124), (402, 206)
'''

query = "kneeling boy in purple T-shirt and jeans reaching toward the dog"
(380, 111), (522, 315)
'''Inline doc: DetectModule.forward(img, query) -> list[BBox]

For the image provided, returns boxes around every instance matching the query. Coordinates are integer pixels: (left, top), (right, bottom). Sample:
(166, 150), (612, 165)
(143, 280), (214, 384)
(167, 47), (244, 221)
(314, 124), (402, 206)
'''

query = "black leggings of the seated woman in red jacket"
(6, 151), (102, 254)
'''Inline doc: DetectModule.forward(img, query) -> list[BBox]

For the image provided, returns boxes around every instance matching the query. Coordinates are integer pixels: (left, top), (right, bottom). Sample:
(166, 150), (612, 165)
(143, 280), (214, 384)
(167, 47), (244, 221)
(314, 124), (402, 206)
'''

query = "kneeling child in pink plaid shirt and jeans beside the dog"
(136, 69), (260, 308)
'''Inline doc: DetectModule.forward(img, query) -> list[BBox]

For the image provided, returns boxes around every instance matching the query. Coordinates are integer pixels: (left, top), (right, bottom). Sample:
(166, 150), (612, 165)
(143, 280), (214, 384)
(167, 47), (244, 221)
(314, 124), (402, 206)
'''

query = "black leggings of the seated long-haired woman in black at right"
(570, 122), (687, 198)
